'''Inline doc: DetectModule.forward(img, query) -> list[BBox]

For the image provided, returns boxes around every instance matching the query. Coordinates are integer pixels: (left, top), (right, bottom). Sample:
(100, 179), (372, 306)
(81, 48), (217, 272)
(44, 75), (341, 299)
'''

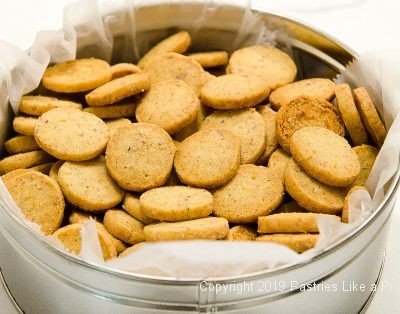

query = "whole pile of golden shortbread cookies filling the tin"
(0, 31), (386, 259)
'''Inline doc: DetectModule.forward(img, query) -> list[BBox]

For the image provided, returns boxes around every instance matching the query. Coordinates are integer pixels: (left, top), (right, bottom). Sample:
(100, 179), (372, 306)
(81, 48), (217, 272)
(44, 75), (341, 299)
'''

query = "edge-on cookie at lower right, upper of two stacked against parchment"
(257, 213), (340, 233)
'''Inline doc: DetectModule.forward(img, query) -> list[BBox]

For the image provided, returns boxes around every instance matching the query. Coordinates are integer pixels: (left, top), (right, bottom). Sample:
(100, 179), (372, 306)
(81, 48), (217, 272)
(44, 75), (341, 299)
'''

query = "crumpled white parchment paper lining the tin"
(0, 0), (400, 278)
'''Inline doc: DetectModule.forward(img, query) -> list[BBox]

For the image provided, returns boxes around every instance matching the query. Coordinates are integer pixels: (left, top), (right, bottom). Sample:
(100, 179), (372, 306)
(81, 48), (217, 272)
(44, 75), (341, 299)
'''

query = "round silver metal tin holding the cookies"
(0, 0), (400, 313)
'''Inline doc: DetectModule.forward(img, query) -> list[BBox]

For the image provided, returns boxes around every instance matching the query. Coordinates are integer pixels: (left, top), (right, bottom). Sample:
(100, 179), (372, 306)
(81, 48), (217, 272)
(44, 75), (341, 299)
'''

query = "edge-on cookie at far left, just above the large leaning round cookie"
(0, 150), (54, 175)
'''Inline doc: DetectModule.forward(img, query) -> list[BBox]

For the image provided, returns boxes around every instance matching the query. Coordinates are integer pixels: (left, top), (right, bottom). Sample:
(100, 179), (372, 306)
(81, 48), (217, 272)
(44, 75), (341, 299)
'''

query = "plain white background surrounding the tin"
(0, 0), (400, 314)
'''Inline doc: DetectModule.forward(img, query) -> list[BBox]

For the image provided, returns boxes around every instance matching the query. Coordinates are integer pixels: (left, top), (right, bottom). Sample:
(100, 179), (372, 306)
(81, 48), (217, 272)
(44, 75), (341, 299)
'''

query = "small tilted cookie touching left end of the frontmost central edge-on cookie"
(103, 209), (144, 244)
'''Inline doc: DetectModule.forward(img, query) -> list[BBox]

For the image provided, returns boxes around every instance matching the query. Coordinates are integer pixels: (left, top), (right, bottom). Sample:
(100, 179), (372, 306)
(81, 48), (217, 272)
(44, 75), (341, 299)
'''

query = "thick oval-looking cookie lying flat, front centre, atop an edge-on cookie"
(140, 186), (213, 221)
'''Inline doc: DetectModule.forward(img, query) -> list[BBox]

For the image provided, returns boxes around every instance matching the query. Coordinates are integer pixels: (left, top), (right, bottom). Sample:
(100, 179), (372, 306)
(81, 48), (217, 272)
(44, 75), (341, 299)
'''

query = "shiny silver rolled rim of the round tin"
(3, 2), (400, 285)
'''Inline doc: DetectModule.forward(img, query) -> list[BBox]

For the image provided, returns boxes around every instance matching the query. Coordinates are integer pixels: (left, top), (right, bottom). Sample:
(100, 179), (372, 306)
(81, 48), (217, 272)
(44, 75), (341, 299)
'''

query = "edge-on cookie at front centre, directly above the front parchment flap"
(144, 217), (229, 242)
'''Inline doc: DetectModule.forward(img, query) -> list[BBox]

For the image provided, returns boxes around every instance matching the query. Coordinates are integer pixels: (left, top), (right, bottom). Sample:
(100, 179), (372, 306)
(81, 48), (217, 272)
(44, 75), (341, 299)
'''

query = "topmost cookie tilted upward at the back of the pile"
(138, 31), (192, 68)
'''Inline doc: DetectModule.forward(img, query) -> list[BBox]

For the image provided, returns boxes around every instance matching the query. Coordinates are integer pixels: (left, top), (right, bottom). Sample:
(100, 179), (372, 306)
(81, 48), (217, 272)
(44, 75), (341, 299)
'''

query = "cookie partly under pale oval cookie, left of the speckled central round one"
(58, 156), (125, 211)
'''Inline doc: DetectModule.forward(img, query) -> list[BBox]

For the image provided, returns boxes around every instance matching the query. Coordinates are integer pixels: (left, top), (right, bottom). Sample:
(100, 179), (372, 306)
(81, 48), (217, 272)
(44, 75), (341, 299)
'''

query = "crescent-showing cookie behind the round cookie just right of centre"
(201, 108), (265, 164)
